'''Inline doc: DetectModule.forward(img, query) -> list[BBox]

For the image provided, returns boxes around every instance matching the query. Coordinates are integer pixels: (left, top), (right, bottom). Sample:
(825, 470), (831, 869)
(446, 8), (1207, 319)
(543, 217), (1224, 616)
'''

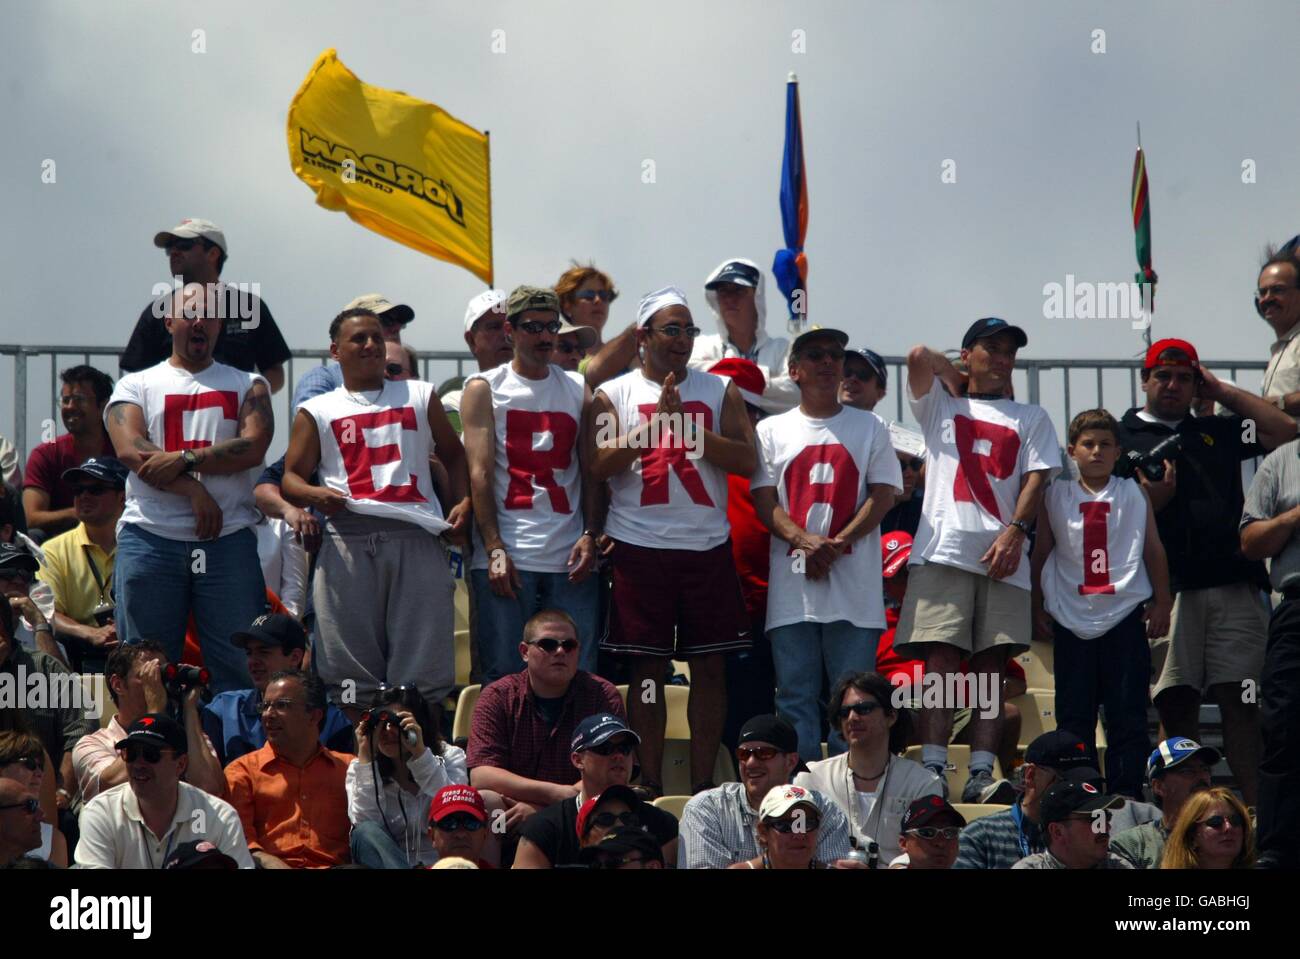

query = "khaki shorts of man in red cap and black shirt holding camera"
(1152, 582), (1269, 697)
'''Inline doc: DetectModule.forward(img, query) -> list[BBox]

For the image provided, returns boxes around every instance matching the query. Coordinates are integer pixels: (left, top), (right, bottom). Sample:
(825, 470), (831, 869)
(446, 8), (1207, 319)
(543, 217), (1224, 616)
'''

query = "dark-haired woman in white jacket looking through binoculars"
(347, 686), (469, 869)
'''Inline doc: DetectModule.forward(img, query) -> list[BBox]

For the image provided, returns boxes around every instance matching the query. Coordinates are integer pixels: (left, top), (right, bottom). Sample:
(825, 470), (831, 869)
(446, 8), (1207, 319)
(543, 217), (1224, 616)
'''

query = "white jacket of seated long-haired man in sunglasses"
(794, 752), (944, 868)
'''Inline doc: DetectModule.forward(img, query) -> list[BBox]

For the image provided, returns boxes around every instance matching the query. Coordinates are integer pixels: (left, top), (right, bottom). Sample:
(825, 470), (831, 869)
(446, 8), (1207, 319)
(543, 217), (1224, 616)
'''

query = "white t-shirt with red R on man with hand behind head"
(907, 377), (1061, 590)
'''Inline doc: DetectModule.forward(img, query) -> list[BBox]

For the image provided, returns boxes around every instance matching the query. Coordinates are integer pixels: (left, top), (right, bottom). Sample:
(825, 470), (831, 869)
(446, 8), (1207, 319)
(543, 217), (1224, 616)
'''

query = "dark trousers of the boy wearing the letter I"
(1053, 606), (1151, 799)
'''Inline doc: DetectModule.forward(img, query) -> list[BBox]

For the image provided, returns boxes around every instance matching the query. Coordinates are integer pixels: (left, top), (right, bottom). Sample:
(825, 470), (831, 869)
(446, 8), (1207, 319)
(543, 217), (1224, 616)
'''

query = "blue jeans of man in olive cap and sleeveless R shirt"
(469, 569), (601, 686)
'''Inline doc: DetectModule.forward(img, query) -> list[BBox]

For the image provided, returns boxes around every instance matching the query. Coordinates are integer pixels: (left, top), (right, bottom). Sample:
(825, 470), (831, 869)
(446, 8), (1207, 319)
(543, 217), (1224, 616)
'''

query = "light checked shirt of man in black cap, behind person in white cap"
(677, 782), (852, 869)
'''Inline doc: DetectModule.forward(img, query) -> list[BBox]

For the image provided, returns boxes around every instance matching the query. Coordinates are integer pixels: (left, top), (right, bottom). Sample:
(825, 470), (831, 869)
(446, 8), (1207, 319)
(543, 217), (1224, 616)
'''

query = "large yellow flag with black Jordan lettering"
(289, 49), (493, 286)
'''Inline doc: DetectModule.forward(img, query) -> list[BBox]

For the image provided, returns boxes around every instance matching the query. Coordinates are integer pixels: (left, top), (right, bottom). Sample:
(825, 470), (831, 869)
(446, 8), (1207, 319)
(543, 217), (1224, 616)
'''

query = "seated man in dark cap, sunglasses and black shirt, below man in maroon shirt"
(515, 712), (677, 869)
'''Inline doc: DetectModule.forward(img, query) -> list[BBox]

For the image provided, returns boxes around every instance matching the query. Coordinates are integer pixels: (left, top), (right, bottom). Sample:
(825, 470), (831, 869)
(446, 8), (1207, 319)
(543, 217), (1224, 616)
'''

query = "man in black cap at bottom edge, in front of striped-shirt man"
(1011, 769), (1134, 869)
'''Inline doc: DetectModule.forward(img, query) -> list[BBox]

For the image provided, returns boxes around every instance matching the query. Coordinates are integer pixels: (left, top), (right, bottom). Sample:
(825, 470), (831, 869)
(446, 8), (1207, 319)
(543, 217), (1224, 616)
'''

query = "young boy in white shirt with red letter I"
(1032, 409), (1174, 799)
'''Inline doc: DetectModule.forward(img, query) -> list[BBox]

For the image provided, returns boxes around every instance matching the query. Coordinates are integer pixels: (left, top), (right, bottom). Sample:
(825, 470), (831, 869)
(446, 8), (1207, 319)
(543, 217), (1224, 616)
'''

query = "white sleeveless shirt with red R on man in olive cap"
(465, 363), (586, 573)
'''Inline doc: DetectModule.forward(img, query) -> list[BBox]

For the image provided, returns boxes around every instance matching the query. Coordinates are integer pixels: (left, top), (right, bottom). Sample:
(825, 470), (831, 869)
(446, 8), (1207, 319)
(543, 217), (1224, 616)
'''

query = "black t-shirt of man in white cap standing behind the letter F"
(118, 286), (290, 373)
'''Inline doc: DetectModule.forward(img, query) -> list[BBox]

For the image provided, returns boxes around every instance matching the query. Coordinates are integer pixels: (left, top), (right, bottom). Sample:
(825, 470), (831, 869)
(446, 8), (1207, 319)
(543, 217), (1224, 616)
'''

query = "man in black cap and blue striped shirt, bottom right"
(953, 729), (1160, 869)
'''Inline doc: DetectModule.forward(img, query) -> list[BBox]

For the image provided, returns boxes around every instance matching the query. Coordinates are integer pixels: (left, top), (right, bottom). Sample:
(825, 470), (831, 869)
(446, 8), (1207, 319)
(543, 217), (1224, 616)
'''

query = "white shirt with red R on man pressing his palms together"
(595, 369), (731, 552)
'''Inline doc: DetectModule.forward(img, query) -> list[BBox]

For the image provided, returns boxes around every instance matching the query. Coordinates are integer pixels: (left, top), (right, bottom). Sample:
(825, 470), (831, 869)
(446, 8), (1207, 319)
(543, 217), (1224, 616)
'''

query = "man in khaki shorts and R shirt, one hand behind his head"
(894, 317), (1061, 803)
